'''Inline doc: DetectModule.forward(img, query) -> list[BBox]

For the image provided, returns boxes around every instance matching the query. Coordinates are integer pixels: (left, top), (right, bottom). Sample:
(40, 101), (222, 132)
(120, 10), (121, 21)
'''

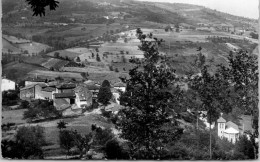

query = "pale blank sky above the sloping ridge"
(138, 0), (259, 19)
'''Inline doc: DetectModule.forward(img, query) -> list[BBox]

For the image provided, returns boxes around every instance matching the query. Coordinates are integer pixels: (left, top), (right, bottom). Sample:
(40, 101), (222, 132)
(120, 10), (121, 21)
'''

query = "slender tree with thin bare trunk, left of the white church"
(189, 66), (232, 159)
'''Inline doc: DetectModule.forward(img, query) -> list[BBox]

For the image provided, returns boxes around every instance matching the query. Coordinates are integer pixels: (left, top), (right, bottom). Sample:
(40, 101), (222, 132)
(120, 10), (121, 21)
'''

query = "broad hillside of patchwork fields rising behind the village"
(2, 0), (257, 78)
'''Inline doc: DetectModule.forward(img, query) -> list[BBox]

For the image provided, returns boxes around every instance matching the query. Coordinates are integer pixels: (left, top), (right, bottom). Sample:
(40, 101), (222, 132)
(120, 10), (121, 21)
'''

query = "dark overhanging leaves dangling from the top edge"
(26, 0), (59, 16)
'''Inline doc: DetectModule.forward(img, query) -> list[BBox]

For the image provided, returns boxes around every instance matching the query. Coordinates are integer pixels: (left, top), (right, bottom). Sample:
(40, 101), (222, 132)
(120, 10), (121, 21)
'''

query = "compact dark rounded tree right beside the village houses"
(97, 80), (112, 106)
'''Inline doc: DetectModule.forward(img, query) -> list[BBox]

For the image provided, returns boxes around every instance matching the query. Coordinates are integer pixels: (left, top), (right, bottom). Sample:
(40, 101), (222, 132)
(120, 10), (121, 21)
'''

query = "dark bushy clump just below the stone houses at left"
(23, 100), (61, 121)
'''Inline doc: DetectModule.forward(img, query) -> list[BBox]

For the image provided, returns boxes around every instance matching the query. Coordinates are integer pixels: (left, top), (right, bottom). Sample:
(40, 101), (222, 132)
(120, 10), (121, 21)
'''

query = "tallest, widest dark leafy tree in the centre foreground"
(117, 29), (182, 159)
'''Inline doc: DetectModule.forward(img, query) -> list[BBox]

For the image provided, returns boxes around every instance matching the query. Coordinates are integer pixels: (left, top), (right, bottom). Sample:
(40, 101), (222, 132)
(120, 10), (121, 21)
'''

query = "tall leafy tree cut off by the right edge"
(218, 51), (259, 158)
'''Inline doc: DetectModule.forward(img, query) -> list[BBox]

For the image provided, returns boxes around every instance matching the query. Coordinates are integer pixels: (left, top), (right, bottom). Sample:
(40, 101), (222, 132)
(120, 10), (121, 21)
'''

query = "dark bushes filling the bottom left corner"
(1, 126), (46, 159)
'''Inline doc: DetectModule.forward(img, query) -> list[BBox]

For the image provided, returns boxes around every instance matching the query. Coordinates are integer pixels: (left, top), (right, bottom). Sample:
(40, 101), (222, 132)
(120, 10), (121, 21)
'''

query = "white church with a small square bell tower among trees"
(217, 117), (239, 143)
